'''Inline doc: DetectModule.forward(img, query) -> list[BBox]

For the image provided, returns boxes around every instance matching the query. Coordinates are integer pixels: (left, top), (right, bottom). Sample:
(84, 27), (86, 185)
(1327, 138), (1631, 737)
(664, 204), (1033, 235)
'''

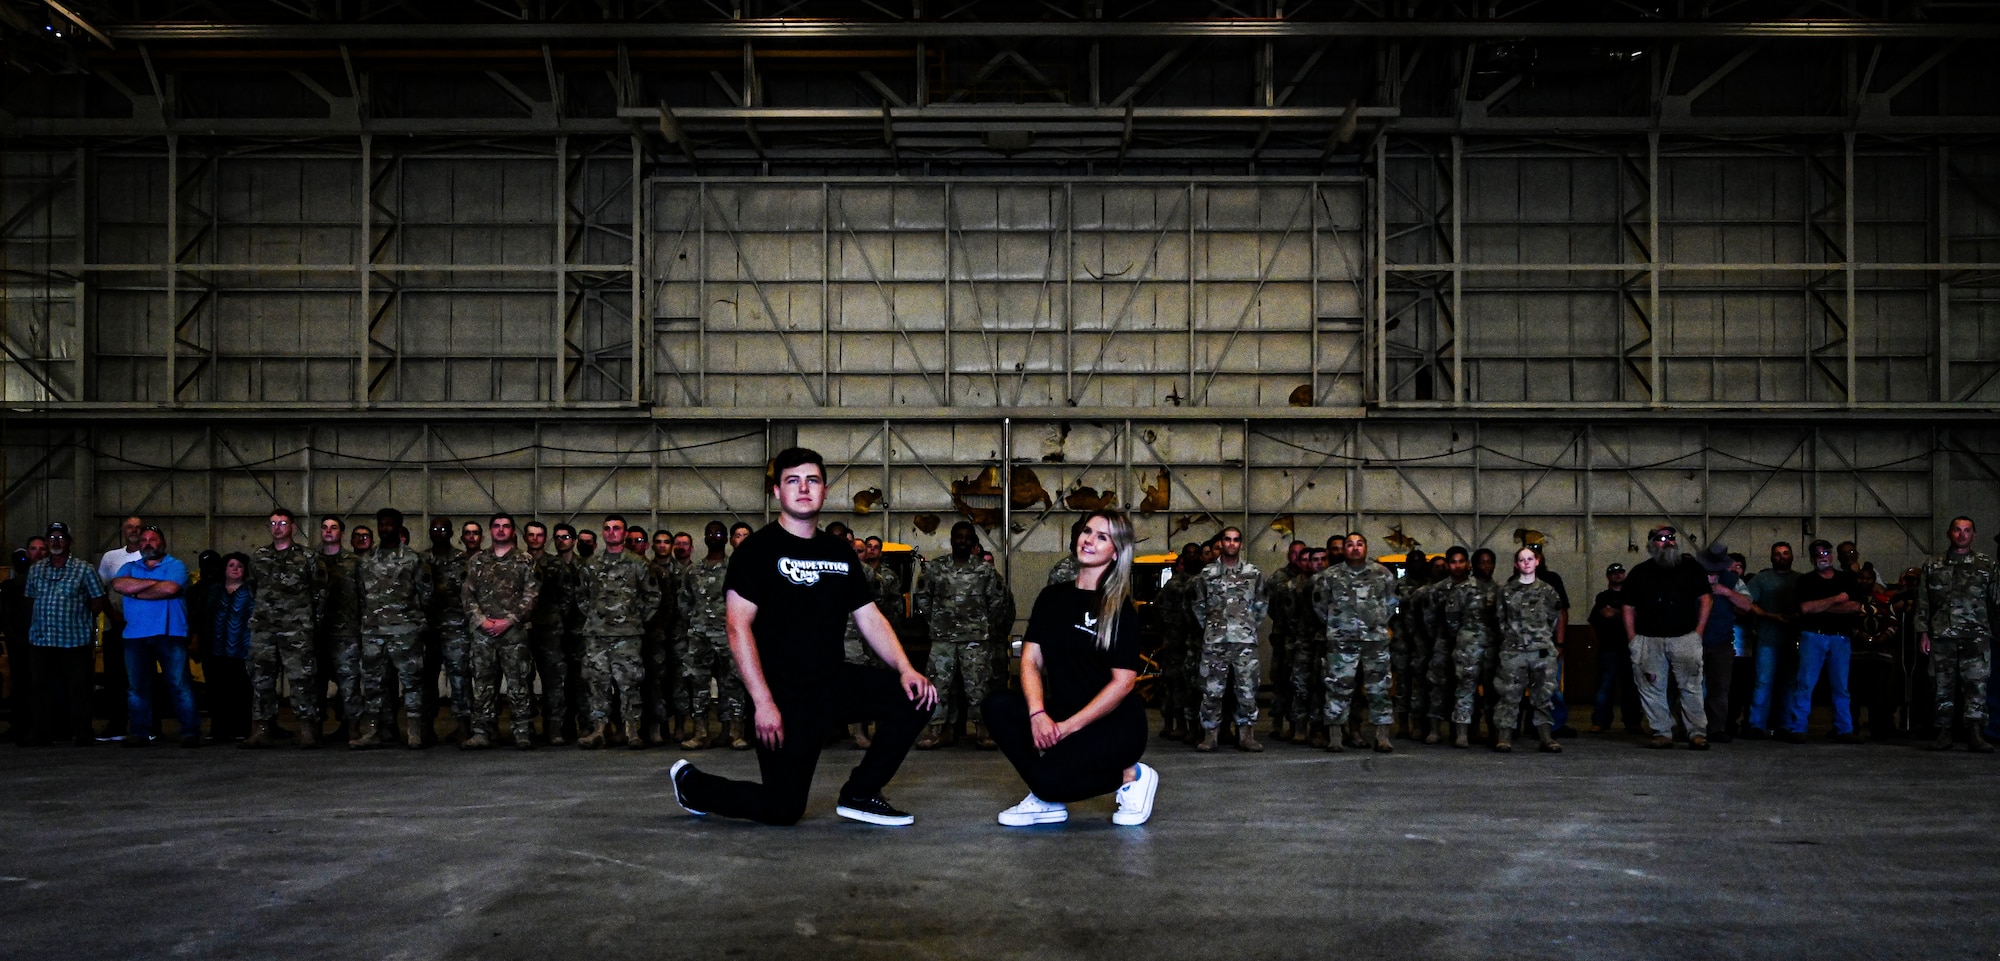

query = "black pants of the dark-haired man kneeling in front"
(680, 665), (930, 825)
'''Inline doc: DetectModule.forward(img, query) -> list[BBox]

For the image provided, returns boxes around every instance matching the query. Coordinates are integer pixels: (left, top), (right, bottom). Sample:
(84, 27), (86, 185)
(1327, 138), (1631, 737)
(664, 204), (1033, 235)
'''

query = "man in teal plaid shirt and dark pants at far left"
(22, 523), (104, 747)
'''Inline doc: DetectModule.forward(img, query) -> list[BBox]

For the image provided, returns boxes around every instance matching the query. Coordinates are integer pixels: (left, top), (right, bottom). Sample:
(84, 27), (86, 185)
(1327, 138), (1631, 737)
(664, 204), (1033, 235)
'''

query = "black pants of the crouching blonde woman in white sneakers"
(986, 691), (1146, 805)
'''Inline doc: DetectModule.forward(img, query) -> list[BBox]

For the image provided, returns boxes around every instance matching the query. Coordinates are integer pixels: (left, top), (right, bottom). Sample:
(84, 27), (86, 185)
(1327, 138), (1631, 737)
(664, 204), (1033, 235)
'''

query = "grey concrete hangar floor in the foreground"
(0, 735), (2000, 961)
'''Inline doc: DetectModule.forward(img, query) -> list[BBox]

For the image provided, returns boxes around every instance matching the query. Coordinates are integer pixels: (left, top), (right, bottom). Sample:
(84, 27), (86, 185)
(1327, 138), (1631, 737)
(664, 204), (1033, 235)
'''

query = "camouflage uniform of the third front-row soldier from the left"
(460, 547), (542, 743)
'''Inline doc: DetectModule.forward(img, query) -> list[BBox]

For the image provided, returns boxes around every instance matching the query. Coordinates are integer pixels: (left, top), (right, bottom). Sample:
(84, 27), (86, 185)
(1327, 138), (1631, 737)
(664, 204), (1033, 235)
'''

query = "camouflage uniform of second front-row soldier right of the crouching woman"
(1312, 561), (1396, 727)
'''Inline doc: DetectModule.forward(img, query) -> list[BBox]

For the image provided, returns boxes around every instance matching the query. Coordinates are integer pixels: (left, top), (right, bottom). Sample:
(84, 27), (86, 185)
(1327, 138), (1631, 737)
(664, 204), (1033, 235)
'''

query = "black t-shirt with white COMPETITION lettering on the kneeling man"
(722, 523), (874, 685)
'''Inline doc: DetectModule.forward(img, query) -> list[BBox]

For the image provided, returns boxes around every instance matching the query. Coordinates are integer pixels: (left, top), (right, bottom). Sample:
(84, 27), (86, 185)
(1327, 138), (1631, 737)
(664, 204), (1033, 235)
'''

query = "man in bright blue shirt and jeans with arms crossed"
(110, 527), (202, 747)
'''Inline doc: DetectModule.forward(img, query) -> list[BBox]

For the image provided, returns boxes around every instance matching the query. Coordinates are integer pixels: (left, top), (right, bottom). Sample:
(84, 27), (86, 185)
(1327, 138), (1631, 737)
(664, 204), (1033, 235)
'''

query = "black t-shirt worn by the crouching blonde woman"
(1022, 583), (1144, 721)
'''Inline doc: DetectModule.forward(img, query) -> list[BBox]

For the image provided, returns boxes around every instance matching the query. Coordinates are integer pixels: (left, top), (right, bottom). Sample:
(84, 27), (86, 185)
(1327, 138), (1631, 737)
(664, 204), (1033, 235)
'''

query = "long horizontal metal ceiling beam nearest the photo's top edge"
(97, 18), (2000, 44)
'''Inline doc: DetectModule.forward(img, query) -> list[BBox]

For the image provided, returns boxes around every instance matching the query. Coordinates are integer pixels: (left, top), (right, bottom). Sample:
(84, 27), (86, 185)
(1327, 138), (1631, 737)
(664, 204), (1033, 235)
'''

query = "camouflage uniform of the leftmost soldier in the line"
(250, 545), (326, 721)
